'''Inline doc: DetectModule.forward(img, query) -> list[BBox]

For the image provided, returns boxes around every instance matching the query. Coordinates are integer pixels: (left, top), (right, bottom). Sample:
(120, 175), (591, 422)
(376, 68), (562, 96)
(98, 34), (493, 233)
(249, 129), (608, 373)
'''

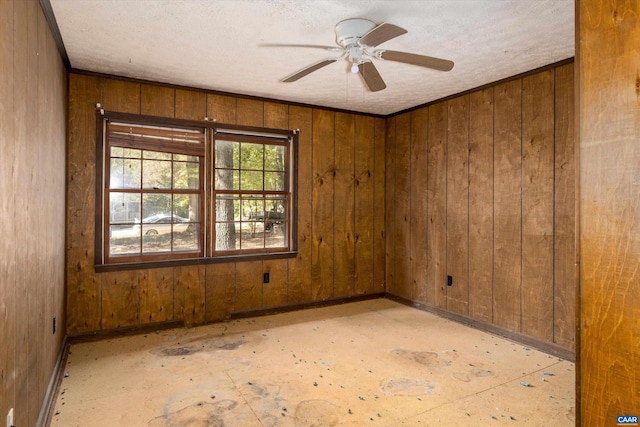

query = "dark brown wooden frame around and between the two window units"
(94, 109), (299, 272)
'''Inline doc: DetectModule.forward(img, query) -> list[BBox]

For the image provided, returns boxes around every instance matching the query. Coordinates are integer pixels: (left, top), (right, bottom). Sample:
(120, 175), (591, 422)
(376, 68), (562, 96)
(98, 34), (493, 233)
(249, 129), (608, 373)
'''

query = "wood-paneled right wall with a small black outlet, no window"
(386, 64), (576, 349)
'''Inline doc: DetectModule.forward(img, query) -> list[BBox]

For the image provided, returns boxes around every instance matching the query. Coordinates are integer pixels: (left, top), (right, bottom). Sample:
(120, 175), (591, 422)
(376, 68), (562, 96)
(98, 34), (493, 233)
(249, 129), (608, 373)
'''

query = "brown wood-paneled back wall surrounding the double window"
(66, 73), (386, 334)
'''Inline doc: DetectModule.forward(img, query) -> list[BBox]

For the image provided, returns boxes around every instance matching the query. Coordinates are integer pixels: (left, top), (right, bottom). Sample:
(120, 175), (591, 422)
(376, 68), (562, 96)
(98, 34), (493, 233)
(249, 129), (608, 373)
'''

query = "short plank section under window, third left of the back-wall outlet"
(173, 265), (205, 327)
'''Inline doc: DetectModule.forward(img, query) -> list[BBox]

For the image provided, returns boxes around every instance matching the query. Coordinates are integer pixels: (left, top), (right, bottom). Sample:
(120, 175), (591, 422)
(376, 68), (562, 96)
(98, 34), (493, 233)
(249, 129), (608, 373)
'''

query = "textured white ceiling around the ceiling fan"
(50, 0), (575, 115)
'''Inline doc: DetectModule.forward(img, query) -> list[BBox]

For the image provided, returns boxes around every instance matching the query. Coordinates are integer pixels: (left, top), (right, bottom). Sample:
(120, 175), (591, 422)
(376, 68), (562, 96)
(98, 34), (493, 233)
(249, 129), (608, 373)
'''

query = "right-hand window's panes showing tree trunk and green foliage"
(214, 138), (290, 251)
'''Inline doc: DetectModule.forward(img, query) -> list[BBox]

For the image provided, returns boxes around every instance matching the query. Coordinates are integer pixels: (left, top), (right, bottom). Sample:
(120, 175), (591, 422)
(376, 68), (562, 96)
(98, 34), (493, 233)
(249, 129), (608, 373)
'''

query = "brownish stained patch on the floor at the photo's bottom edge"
(148, 400), (238, 427)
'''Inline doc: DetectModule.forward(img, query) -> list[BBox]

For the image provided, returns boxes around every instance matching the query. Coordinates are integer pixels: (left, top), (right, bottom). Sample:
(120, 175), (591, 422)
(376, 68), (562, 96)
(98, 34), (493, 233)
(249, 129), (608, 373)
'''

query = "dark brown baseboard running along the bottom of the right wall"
(384, 293), (576, 362)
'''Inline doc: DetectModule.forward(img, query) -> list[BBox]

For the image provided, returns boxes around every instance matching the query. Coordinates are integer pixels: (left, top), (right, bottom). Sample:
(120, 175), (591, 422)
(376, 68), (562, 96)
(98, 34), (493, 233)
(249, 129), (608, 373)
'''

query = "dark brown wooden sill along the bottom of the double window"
(94, 251), (298, 273)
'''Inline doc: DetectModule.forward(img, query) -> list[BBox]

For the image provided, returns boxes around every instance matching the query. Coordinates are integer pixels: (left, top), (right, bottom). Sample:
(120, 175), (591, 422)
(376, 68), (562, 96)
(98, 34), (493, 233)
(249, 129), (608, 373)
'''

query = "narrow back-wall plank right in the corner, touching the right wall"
(373, 118), (387, 292)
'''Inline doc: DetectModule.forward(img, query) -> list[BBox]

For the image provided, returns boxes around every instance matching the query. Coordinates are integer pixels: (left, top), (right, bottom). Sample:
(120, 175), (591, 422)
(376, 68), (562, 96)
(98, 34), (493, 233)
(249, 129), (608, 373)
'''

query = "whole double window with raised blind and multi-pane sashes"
(96, 113), (297, 266)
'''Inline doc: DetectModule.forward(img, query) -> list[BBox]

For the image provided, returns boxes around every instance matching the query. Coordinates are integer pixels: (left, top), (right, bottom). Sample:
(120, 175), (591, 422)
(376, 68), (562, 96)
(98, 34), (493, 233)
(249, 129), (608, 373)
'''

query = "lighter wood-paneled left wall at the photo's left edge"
(0, 0), (67, 426)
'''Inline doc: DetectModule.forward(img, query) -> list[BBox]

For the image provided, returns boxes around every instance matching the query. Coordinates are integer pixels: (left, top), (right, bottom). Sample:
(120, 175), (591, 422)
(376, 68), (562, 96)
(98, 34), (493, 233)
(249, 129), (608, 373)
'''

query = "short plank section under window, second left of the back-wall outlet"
(205, 262), (236, 322)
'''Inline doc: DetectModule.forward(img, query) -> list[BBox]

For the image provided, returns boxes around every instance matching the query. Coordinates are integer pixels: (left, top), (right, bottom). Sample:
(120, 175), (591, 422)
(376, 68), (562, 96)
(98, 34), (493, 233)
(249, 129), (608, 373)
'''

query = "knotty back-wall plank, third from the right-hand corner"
(333, 113), (355, 297)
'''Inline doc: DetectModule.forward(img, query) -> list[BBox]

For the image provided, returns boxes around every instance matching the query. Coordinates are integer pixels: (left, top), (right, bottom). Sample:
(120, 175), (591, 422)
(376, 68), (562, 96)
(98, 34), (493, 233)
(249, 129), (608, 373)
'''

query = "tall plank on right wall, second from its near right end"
(522, 70), (554, 342)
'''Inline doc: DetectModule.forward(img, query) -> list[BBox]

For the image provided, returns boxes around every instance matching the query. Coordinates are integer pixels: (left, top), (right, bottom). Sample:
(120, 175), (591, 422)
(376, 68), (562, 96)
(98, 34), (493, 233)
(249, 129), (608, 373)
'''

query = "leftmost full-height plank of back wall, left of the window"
(66, 74), (102, 334)
